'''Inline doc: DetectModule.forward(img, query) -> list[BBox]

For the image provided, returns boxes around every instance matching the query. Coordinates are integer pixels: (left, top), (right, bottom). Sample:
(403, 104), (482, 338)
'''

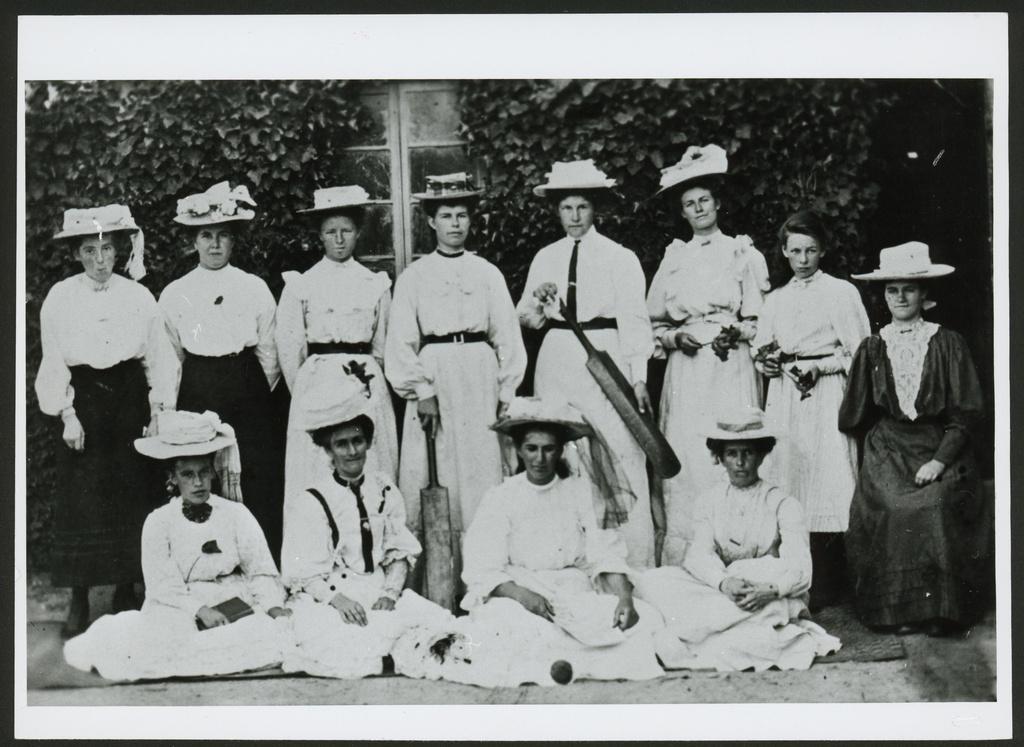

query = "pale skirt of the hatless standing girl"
(761, 374), (857, 532)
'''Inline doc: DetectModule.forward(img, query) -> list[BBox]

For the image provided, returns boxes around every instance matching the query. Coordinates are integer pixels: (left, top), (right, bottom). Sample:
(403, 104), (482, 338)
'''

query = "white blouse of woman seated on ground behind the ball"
(462, 472), (629, 610)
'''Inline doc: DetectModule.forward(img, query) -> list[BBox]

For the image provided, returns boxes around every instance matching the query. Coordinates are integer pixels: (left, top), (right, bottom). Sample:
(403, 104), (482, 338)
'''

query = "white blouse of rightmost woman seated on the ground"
(683, 481), (811, 596)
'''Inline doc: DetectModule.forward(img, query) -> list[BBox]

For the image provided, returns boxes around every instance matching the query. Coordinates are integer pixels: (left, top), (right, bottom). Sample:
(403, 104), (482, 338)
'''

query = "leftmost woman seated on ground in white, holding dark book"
(65, 411), (290, 680)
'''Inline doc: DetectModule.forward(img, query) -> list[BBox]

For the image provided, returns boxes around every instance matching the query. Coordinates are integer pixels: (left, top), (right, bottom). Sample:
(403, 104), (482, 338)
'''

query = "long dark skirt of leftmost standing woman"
(51, 360), (156, 586)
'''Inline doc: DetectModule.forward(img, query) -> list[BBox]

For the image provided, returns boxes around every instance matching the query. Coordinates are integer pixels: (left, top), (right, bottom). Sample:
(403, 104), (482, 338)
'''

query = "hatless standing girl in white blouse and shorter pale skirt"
(753, 210), (870, 612)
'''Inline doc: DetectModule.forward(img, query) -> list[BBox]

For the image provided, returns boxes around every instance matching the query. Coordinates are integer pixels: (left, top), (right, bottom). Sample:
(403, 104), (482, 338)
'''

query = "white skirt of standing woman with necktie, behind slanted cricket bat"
(534, 329), (654, 568)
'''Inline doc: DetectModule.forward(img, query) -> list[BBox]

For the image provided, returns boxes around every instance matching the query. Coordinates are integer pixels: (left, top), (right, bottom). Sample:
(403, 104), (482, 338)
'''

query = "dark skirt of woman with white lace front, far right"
(846, 418), (992, 625)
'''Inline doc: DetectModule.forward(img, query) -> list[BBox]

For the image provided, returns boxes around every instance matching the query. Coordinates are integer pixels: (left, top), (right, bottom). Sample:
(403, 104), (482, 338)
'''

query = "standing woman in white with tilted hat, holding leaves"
(647, 146), (769, 565)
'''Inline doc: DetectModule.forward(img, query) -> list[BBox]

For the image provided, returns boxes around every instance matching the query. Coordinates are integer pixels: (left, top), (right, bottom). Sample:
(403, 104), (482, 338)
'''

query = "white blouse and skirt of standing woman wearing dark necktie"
(517, 227), (654, 568)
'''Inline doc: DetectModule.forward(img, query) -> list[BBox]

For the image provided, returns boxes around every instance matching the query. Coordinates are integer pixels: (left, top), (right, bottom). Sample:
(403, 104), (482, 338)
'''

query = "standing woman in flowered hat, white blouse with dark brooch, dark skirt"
(160, 181), (284, 559)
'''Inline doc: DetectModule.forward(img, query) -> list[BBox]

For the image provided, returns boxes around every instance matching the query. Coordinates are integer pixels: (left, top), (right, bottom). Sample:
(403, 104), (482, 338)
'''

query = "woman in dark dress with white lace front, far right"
(839, 242), (991, 635)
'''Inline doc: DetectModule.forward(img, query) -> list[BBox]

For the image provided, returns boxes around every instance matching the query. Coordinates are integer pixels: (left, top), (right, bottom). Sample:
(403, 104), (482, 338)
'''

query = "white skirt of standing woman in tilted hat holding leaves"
(659, 342), (761, 566)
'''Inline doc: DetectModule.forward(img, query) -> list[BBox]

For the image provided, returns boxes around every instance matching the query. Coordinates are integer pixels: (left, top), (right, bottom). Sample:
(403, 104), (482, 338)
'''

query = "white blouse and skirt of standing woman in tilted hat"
(647, 232), (769, 565)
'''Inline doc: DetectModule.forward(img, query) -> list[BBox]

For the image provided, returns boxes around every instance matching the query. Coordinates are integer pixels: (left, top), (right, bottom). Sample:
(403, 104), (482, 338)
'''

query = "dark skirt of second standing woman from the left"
(177, 347), (285, 562)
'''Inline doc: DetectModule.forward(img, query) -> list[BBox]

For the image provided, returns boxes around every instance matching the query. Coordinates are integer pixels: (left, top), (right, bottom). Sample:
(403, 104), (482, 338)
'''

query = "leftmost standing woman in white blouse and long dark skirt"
(36, 205), (178, 636)
